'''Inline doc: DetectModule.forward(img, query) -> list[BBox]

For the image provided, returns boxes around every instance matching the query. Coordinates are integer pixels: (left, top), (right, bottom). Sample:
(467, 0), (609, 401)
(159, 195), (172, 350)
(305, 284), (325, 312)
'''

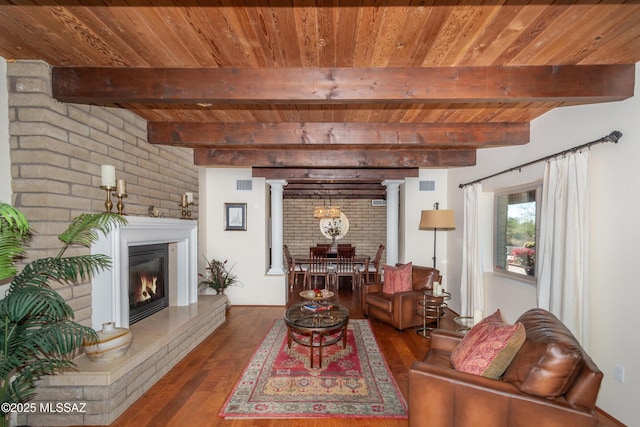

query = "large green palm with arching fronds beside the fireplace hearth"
(0, 203), (126, 426)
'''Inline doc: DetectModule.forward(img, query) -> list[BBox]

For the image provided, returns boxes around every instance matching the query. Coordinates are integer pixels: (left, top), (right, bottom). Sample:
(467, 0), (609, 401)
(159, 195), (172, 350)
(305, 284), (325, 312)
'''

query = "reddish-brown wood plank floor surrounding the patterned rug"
(111, 280), (616, 427)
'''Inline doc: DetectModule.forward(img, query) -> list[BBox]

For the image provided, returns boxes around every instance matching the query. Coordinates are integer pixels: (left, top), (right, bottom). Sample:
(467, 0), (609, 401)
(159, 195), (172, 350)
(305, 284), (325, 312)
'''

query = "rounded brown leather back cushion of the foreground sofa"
(503, 309), (583, 399)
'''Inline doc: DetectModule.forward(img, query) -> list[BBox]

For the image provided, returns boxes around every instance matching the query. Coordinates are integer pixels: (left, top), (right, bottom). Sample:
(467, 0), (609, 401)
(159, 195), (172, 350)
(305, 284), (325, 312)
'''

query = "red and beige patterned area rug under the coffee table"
(219, 319), (407, 419)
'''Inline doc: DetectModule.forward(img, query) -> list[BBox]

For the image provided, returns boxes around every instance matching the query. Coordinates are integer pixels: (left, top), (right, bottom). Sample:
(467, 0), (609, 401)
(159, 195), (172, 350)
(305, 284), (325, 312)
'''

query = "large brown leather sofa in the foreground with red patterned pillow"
(409, 309), (603, 427)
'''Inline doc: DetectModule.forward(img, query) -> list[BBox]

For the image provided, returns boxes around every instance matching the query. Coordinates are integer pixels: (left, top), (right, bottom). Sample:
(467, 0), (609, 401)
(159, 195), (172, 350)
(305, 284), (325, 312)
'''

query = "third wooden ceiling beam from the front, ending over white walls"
(194, 149), (476, 168)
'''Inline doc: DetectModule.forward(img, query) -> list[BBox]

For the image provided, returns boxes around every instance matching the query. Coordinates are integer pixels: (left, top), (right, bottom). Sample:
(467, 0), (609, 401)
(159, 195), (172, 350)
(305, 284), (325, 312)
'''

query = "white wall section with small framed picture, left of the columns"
(198, 168), (287, 305)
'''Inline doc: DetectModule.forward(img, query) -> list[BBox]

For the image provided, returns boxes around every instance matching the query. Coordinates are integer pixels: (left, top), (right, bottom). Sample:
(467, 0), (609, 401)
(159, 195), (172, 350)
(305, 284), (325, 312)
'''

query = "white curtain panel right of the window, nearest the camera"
(537, 150), (590, 348)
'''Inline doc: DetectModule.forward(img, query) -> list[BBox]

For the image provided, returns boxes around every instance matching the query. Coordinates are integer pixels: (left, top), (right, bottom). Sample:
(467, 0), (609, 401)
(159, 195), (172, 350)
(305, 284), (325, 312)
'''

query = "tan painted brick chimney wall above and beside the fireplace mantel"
(7, 61), (198, 325)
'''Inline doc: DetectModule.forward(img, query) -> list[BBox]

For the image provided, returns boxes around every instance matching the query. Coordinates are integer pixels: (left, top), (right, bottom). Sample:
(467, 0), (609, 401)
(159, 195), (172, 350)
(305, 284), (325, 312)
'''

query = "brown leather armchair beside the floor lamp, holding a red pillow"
(361, 264), (442, 330)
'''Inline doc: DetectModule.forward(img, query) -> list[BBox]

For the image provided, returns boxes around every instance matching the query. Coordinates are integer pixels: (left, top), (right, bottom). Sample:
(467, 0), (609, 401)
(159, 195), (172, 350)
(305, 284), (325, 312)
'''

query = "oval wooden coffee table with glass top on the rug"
(284, 301), (349, 368)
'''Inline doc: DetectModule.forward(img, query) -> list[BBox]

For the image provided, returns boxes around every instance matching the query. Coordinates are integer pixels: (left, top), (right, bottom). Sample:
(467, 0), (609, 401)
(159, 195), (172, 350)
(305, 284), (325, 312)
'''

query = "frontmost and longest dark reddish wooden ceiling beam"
(52, 64), (635, 104)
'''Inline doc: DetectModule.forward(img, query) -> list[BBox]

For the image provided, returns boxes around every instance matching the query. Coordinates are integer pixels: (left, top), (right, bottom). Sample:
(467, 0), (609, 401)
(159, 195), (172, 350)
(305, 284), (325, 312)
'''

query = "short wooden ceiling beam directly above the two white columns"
(252, 167), (420, 183)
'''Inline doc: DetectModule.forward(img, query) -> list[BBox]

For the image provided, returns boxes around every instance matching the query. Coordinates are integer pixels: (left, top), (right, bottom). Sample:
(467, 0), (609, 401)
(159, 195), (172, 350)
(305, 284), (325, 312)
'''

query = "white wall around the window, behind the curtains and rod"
(447, 61), (640, 426)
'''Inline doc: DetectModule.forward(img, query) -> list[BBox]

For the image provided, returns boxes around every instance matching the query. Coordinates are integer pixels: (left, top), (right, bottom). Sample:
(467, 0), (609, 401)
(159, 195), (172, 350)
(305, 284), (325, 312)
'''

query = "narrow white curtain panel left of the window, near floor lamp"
(460, 184), (484, 316)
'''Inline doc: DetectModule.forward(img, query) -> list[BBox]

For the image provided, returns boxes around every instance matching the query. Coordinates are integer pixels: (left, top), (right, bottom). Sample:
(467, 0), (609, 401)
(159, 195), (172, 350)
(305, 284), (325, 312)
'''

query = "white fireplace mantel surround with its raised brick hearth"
(18, 217), (227, 426)
